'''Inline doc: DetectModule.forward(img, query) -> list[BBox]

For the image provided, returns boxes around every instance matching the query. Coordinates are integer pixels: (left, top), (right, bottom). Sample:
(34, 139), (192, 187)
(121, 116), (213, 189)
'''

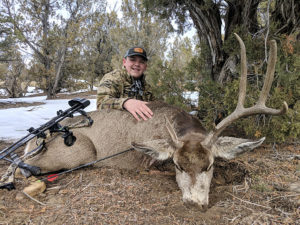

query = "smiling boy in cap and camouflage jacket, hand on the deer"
(97, 47), (154, 121)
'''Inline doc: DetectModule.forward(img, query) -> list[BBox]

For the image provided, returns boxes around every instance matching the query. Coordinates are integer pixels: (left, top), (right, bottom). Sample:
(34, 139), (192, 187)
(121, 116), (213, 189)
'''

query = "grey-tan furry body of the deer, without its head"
(25, 102), (191, 173)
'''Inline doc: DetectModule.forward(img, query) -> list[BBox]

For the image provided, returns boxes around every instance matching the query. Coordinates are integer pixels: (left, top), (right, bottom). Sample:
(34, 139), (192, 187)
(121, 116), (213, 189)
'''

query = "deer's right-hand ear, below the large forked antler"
(212, 137), (265, 159)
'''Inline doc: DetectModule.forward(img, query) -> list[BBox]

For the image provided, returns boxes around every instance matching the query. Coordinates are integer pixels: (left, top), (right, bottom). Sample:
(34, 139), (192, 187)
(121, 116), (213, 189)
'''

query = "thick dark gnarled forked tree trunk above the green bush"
(186, 0), (259, 83)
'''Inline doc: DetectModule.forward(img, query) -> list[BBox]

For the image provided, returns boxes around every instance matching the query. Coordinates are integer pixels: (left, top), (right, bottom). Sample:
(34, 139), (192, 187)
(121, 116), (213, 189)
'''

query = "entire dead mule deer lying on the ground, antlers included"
(25, 35), (288, 207)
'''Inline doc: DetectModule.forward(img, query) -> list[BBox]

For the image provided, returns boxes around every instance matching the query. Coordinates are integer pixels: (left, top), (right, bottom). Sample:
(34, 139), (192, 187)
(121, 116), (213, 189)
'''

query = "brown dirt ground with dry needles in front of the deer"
(0, 92), (300, 225)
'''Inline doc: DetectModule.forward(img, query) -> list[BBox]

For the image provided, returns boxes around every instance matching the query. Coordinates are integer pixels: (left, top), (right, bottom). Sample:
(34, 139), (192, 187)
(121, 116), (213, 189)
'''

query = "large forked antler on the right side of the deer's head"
(202, 33), (288, 146)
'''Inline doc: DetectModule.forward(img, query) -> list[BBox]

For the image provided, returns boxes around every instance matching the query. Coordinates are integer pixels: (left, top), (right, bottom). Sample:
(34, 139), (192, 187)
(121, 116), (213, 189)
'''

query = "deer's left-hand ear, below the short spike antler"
(131, 139), (176, 160)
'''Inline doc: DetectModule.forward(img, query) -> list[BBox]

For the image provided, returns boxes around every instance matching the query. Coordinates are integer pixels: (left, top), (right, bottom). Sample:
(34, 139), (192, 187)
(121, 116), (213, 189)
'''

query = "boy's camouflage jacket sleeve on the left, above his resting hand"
(97, 70), (128, 109)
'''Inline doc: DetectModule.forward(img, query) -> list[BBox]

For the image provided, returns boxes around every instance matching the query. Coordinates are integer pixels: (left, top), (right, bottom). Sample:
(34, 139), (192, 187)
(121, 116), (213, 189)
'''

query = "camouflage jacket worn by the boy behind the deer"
(97, 69), (154, 109)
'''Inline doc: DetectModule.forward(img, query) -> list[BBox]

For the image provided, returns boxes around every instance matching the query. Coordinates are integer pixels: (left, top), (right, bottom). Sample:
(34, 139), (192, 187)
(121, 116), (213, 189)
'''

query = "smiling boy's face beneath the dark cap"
(123, 55), (147, 78)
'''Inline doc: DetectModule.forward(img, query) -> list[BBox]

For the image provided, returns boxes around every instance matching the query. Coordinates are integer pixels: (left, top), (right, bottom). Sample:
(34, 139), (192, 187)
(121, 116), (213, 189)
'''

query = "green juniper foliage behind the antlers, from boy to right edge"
(147, 27), (300, 142)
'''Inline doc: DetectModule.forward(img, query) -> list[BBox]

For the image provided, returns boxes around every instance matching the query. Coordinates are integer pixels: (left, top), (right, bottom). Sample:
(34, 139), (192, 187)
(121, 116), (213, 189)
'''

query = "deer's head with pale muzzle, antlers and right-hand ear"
(166, 34), (288, 208)
